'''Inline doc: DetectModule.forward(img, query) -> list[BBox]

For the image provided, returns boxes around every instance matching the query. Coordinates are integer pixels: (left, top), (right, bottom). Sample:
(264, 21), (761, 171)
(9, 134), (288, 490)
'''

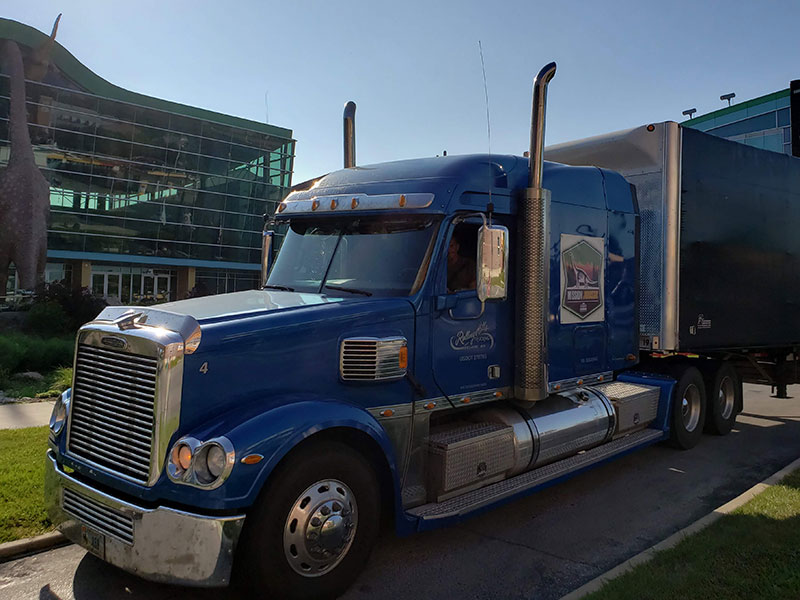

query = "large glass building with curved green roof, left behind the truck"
(0, 19), (295, 304)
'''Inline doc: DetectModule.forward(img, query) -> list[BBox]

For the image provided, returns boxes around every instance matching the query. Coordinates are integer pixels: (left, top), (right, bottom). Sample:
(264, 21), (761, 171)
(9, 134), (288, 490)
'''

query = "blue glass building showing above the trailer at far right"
(682, 89), (792, 155)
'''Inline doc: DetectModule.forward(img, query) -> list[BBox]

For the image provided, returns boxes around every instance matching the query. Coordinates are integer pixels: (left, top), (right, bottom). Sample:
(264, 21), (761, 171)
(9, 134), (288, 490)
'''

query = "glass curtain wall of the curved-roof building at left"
(0, 68), (294, 270)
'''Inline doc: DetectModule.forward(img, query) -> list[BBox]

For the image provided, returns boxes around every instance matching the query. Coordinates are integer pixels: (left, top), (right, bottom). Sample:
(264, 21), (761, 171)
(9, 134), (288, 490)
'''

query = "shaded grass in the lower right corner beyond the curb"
(586, 470), (800, 600)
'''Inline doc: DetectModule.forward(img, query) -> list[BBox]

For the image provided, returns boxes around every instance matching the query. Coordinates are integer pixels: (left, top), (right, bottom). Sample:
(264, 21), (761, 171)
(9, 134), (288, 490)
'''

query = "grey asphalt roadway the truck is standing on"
(0, 385), (800, 600)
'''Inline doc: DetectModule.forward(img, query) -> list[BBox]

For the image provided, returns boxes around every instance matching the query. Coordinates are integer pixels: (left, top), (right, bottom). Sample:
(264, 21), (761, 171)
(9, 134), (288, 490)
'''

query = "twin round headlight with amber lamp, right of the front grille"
(167, 437), (236, 489)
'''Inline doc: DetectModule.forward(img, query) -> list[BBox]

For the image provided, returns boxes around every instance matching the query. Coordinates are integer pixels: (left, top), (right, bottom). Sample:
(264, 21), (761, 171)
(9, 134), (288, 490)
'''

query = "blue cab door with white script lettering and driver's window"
(431, 219), (514, 406)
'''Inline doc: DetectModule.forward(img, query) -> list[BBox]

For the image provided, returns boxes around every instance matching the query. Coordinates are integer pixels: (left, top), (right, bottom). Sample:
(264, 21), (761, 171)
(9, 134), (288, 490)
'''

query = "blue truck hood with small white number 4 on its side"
(177, 291), (415, 432)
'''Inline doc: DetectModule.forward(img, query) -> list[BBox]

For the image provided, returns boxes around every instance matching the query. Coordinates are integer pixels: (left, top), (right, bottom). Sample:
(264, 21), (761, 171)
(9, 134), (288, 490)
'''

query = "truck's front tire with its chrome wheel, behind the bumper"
(236, 442), (380, 599)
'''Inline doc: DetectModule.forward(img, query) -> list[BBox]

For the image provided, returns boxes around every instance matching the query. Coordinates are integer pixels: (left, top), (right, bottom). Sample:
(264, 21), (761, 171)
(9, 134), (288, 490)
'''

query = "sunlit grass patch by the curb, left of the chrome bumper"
(0, 427), (53, 543)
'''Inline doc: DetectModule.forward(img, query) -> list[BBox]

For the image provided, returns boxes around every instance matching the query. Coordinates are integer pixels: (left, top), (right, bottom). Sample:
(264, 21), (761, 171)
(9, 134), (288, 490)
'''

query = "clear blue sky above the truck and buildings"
(6, 0), (800, 183)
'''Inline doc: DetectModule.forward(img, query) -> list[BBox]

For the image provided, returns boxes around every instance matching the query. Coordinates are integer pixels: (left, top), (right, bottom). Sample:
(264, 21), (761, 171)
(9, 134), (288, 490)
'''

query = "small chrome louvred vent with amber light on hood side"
(339, 337), (408, 381)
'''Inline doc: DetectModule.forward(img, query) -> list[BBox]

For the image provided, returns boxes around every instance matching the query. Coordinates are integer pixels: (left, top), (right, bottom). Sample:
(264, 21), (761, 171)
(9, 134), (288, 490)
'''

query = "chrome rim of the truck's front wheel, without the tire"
(283, 479), (358, 577)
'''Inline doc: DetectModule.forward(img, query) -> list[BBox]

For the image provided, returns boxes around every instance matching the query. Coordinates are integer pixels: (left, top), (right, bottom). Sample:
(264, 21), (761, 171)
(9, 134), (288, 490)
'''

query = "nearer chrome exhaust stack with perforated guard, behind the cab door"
(514, 62), (556, 402)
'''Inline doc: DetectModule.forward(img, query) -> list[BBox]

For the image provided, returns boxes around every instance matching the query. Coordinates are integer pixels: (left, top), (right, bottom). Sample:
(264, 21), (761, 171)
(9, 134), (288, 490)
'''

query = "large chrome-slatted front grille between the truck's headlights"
(67, 344), (158, 484)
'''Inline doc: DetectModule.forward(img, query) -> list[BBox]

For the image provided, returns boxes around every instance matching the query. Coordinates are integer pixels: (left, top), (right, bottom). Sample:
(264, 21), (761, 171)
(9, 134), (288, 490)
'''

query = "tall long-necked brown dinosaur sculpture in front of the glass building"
(0, 40), (50, 295)
